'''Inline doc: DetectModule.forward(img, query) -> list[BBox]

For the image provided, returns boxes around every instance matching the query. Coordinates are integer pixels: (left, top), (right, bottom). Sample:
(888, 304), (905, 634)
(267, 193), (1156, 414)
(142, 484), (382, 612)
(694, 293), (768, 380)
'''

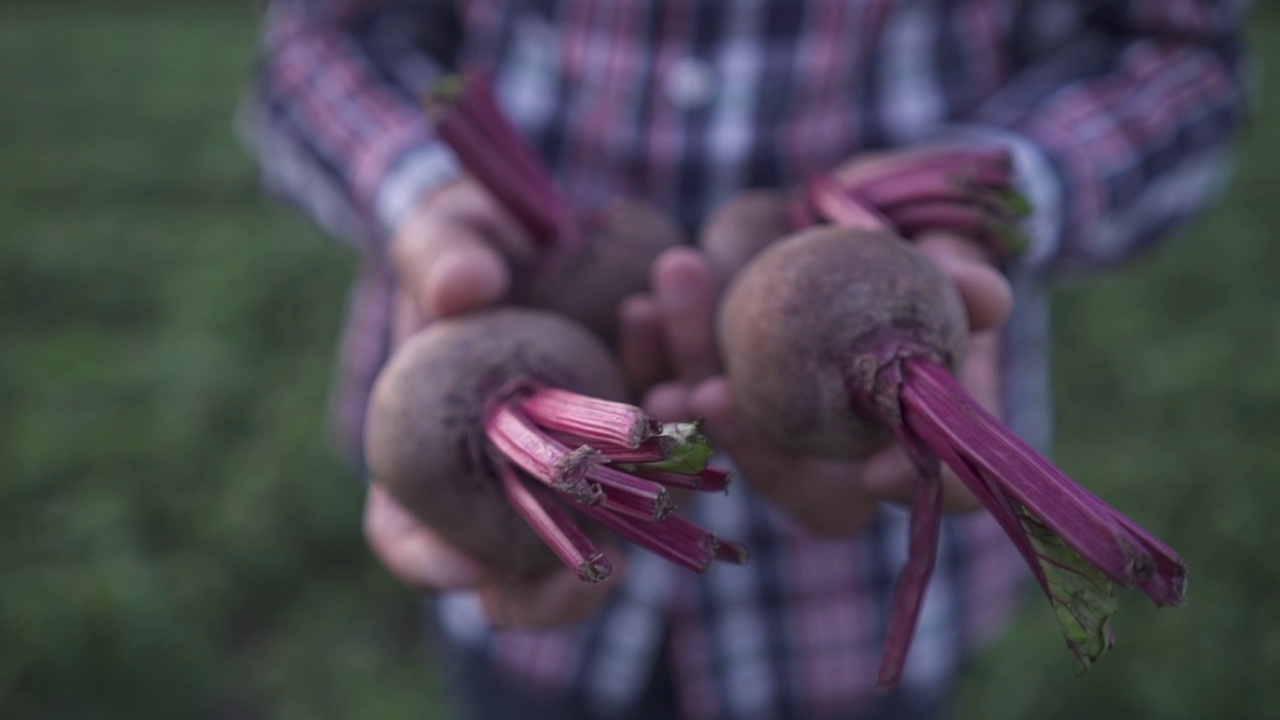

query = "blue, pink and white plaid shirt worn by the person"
(242, 0), (1245, 719)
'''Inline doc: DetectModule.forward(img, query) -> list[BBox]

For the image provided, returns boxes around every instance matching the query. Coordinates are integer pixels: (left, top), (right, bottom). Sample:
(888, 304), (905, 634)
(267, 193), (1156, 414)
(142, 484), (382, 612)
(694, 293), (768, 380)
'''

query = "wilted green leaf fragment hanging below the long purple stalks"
(1018, 507), (1120, 675)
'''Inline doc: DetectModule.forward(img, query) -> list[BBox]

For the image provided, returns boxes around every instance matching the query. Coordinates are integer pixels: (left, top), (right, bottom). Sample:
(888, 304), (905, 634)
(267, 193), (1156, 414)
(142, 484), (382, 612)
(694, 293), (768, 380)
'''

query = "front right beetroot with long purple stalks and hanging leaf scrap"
(717, 227), (1185, 689)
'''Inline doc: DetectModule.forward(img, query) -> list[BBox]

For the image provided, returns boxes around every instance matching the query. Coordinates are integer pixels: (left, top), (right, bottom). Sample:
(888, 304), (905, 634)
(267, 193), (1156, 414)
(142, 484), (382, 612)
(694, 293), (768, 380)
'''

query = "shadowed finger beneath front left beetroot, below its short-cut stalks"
(480, 552), (626, 629)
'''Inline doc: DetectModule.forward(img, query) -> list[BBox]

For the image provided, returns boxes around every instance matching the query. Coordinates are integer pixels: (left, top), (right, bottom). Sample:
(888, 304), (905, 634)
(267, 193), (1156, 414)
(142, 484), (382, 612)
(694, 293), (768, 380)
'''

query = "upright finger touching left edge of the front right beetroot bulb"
(652, 247), (719, 383)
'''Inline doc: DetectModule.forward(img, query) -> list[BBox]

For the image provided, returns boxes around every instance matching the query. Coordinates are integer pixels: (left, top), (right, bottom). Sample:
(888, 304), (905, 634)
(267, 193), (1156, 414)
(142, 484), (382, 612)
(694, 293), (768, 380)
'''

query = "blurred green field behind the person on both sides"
(0, 0), (1280, 720)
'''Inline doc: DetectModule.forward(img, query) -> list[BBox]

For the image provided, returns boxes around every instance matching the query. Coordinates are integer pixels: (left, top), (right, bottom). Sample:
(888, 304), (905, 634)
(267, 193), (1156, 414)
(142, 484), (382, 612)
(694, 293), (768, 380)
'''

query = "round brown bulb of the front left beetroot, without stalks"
(365, 309), (625, 575)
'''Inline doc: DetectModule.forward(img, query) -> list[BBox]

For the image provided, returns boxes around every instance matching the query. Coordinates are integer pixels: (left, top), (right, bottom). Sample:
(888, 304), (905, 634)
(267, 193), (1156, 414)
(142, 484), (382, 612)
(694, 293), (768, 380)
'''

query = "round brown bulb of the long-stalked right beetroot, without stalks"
(717, 227), (968, 460)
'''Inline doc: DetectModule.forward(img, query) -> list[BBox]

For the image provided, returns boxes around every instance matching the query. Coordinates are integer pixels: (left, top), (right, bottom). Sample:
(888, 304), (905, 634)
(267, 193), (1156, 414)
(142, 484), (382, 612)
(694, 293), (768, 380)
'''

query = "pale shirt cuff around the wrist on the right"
(932, 124), (1066, 266)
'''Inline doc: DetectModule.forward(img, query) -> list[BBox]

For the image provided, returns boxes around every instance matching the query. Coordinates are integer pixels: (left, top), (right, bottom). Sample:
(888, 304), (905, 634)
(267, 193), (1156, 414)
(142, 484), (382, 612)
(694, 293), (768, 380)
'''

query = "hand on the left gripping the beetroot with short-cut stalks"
(364, 178), (623, 626)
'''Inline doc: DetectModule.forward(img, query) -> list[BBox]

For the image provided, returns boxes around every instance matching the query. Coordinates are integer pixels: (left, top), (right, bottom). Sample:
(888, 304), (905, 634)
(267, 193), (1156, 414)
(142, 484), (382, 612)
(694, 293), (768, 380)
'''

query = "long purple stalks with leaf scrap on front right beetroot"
(850, 331), (1187, 689)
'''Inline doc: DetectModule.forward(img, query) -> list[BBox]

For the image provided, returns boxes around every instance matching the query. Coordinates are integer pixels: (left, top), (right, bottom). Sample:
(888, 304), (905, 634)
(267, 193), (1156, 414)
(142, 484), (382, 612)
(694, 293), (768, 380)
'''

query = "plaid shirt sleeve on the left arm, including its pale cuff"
(238, 0), (461, 254)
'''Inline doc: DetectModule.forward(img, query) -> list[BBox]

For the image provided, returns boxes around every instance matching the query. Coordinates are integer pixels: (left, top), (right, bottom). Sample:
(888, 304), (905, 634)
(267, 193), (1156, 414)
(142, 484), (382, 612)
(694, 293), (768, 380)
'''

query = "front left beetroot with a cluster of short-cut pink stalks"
(365, 307), (740, 582)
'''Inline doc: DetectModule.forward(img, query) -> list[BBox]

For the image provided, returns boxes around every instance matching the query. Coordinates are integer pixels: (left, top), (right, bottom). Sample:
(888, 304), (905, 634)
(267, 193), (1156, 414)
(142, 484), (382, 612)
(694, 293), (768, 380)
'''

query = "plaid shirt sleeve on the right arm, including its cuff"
(943, 0), (1247, 272)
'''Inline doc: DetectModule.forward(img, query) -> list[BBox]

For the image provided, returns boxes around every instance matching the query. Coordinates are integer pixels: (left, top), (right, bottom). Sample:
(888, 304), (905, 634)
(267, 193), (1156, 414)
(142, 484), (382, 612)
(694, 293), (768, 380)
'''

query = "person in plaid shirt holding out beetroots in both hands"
(242, 0), (1247, 719)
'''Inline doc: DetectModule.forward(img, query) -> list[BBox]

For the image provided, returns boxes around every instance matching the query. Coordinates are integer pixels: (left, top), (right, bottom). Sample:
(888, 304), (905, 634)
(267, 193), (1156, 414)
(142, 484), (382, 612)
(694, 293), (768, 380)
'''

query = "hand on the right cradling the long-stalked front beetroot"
(621, 234), (1012, 536)
